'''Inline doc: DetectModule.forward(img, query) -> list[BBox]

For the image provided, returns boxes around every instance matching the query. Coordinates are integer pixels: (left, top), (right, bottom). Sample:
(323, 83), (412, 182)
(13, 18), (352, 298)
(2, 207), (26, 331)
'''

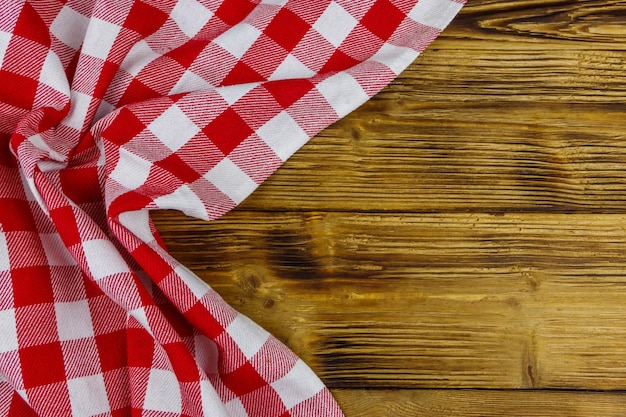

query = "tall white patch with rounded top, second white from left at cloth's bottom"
(143, 369), (182, 414)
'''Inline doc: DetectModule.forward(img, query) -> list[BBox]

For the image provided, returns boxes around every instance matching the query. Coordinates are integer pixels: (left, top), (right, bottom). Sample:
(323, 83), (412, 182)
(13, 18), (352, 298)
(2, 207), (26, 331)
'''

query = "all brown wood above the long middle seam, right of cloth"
(232, 0), (626, 212)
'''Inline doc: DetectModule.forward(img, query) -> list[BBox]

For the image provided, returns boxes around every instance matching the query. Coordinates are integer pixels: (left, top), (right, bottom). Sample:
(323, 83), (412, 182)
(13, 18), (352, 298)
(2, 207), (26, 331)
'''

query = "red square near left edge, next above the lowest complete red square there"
(11, 266), (54, 307)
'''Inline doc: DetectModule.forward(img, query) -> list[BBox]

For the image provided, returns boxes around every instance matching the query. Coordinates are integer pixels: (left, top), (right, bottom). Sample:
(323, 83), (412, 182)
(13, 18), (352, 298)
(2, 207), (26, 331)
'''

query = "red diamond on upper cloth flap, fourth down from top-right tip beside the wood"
(202, 108), (253, 155)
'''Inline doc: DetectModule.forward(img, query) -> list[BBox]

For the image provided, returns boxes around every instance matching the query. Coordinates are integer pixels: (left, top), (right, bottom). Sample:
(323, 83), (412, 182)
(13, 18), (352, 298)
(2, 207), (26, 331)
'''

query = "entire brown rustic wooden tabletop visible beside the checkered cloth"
(154, 0), (626, 417)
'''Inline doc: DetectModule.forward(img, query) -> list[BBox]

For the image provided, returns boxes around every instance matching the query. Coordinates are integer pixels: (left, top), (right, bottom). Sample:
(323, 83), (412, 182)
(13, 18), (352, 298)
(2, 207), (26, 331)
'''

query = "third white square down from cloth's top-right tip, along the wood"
(316, 72), (369, 118)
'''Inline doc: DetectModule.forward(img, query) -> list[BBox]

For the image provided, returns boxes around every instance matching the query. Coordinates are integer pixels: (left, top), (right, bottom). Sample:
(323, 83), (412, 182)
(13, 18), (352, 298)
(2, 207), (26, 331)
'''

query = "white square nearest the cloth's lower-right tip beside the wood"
(271, 360), (324, 409)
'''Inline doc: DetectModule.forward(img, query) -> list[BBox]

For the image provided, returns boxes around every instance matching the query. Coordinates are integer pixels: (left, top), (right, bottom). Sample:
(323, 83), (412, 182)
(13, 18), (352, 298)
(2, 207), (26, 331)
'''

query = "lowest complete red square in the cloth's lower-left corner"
(20, 342), (66, 389)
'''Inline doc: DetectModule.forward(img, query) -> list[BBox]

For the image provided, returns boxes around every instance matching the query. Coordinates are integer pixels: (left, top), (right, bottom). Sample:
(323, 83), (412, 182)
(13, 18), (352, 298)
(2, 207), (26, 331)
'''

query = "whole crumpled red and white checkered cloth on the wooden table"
(0, 0), (463, 417)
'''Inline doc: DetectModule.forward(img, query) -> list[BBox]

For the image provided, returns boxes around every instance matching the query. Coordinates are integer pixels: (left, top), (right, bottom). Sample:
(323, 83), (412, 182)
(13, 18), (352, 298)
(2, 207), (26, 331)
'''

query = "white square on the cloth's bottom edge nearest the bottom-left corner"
(67, 374), (110, 417)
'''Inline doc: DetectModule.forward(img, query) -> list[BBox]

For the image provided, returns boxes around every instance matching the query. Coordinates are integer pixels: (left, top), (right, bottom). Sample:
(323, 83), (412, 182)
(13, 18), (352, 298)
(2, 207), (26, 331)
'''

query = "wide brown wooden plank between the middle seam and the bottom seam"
(155, 210), (626, 390)
